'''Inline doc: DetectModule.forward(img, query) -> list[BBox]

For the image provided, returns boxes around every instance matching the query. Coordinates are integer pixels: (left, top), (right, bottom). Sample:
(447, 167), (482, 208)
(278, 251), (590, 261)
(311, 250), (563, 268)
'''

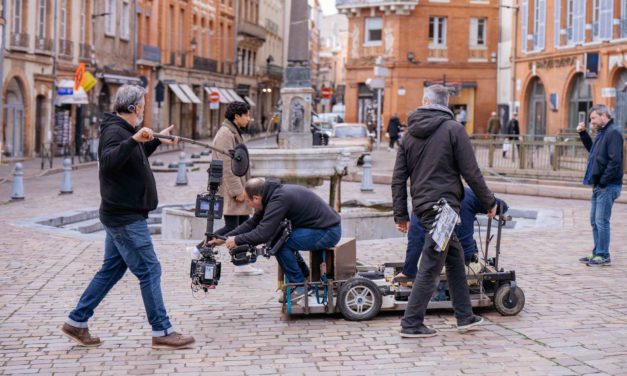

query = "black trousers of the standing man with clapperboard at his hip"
(401, 210), (473, 328)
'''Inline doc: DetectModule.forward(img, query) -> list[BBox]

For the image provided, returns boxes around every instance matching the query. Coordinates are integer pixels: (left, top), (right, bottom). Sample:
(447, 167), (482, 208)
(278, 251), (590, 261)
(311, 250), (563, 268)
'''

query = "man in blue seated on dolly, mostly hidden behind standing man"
(397, 187), (509, 278)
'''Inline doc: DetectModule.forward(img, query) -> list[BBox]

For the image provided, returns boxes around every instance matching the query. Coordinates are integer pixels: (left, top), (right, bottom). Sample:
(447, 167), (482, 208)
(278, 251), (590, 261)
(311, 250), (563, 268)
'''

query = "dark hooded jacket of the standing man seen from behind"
(392, 106), (496, 223)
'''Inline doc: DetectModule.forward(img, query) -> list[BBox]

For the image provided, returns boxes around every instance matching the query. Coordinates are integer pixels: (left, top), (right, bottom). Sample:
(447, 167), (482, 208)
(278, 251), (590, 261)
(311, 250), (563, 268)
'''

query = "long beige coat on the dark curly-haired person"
(212, 119), (252, 215)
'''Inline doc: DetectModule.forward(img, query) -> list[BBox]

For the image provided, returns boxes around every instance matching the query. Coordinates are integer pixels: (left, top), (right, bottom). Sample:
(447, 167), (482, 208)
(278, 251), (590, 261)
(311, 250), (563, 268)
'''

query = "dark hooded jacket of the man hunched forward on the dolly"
(226, 180), (340, 245)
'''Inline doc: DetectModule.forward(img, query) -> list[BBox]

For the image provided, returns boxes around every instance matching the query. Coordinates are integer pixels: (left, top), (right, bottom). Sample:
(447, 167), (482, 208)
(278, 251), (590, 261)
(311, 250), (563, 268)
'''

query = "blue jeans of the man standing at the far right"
(590, 184), (622, 258)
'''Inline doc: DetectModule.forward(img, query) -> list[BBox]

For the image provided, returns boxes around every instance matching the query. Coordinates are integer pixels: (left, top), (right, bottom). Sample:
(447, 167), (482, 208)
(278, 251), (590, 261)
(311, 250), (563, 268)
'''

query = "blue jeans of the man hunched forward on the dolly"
(276, 224), (342, 283)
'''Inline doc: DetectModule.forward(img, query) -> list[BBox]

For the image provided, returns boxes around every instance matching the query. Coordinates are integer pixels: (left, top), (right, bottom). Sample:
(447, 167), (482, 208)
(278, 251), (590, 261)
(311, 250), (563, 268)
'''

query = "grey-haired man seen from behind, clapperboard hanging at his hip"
(392, 85), (496, 337)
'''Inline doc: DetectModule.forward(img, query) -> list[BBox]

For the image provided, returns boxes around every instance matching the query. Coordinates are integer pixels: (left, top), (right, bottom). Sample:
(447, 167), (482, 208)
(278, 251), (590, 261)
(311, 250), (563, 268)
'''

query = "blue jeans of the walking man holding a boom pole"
(67, 220), (174, 337)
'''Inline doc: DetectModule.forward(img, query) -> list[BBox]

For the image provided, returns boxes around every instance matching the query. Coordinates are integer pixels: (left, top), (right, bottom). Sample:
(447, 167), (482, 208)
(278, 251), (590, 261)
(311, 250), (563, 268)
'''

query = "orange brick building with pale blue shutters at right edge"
(513, 0), (627, 136)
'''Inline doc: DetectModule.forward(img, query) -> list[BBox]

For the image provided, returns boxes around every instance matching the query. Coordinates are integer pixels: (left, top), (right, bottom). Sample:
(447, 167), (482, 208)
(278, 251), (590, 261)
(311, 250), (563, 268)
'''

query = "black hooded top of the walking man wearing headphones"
(98, 113), (161, 227)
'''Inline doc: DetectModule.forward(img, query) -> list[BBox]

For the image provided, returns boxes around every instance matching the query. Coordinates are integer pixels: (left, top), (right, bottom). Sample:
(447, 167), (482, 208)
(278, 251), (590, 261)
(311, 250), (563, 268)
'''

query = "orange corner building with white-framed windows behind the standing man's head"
(336, 0), (499, 133)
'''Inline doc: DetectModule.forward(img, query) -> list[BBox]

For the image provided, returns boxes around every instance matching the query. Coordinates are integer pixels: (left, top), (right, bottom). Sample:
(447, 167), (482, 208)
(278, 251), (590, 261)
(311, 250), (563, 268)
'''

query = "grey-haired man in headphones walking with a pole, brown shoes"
(61, 85), (194, 349)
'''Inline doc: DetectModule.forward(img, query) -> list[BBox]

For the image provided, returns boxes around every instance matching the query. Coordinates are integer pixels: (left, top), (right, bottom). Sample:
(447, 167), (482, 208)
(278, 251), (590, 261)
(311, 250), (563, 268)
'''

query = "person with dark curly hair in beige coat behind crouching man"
(213, 102), (263, 275)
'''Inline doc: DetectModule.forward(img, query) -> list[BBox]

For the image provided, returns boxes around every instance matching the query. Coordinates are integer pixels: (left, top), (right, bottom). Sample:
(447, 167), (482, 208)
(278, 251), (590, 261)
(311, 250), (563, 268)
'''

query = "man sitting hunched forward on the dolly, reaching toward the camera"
(210, 178), (342, 299)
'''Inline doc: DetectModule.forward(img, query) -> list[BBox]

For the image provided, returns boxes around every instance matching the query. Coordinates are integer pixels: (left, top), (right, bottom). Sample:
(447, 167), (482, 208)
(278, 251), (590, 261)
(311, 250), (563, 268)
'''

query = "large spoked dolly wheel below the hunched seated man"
(338, 277), (382, 321)
